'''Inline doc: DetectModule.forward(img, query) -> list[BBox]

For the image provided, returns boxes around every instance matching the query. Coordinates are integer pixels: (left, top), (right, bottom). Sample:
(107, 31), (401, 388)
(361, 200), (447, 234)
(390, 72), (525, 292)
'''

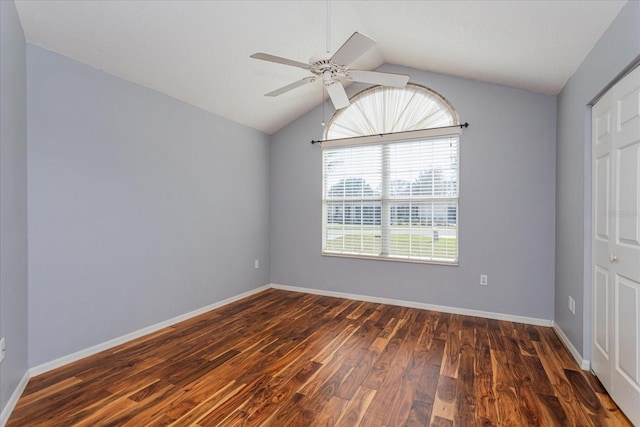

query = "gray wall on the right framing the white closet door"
(555, 1), (640, 359)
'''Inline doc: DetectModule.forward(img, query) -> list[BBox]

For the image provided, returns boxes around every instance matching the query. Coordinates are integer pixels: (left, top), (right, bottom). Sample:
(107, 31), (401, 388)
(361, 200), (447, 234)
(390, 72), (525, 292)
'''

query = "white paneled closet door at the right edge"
(592, 68), (640, 426)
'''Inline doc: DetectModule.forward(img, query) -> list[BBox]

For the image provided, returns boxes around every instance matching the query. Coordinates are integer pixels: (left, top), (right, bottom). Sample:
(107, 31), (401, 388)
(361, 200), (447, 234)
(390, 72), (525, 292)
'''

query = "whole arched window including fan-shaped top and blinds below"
(322, 84), (460, 264)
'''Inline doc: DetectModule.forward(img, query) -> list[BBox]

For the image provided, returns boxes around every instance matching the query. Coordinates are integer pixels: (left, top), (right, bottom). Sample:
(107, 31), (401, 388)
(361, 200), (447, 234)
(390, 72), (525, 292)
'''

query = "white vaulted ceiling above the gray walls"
(15, 0), (626, 134)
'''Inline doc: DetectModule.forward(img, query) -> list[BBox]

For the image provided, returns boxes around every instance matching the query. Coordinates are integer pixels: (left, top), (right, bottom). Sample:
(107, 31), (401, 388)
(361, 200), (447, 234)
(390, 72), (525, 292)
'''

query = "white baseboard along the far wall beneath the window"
(271, 283), (553, 326)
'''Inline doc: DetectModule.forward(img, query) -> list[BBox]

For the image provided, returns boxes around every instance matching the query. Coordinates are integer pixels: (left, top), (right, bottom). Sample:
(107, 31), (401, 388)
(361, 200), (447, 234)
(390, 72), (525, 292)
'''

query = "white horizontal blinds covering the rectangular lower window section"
(323, 135), (459, 264)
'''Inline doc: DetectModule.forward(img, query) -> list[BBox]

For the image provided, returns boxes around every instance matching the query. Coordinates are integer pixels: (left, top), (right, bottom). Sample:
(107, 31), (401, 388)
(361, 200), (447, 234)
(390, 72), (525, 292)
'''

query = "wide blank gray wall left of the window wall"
(27, 44), (270, 366)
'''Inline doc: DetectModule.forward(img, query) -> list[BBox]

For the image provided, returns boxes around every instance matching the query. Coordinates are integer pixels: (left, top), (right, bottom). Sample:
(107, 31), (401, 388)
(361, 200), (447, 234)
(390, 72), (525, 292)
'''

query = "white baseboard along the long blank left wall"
(29, 285), (271, 377)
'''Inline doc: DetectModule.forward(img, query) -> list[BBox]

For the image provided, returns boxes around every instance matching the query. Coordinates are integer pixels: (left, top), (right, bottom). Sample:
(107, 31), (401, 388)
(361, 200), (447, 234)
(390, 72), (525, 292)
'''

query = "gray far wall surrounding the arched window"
(271, 65), (556, 319)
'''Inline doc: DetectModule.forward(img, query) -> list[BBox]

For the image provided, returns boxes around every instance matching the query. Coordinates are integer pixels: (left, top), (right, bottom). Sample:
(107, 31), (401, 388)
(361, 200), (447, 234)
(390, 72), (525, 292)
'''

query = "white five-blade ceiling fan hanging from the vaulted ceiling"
(251, 32), (409, 110)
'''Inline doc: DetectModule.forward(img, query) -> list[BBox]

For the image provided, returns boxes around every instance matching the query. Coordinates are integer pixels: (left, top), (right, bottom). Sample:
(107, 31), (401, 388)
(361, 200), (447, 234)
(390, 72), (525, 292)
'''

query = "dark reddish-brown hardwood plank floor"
(7, 289), (630, 427)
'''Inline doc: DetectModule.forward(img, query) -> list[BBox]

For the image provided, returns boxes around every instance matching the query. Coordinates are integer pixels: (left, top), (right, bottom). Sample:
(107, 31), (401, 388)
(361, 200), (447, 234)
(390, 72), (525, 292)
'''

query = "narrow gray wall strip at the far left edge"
(0, 1), (27, 411)
